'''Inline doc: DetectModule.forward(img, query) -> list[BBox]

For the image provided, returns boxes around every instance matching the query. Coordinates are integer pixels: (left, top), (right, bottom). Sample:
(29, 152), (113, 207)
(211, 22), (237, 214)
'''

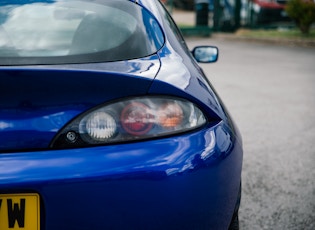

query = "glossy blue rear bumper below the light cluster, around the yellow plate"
(0, 122), (242, 230)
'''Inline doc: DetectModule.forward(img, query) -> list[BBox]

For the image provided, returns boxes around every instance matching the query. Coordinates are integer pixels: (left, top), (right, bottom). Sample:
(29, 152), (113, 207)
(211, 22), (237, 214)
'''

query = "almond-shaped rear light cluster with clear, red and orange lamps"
(51, 97), (206, 148)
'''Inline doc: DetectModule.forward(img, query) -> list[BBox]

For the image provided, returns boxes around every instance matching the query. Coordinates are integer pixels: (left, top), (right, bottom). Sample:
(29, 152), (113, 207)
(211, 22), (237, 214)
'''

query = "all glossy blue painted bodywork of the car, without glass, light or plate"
(0, 0), (243, 230)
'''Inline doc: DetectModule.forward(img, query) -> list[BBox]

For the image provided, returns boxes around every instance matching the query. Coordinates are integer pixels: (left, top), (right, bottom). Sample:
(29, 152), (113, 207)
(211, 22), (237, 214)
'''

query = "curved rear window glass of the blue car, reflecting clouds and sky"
(0, 0), (164, 65)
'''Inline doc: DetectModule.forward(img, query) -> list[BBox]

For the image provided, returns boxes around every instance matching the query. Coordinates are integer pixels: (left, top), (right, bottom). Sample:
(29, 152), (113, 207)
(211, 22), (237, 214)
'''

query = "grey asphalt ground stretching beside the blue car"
(186, 38), (315, 230)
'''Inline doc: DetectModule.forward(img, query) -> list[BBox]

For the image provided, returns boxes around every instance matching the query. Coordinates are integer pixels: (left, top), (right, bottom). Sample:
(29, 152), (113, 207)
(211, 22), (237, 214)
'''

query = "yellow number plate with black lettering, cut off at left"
(0, 193), (40, 230)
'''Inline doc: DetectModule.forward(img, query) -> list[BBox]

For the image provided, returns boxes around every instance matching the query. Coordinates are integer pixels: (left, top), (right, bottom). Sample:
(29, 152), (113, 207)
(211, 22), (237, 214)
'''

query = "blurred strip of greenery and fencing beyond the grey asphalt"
(162, 0), (315, 45)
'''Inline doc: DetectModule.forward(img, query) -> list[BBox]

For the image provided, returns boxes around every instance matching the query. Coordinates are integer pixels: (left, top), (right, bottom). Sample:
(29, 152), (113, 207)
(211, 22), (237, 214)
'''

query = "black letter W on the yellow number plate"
(7, 199), (25, 228)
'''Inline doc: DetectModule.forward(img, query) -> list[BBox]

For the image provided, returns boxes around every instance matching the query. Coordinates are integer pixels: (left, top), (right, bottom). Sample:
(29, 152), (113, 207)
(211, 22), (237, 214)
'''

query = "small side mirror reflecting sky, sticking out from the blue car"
(192, 46), (219, 63)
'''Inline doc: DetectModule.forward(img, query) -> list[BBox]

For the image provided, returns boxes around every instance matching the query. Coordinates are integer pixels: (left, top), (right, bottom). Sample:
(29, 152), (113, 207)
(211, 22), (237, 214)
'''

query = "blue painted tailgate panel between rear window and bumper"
(0, 56), (160, 152)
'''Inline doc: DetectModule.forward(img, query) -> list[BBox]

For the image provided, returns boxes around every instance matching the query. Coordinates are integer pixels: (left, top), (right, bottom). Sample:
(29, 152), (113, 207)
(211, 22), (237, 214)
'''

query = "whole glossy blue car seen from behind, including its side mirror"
(0, 0), (243, 230)
